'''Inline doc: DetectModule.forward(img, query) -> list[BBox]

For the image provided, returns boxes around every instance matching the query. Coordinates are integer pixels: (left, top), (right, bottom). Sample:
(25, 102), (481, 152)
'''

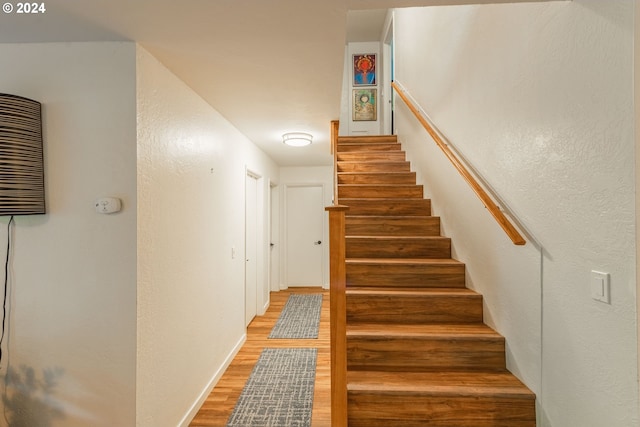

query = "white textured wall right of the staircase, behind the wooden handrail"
(395, 0), (638, 427)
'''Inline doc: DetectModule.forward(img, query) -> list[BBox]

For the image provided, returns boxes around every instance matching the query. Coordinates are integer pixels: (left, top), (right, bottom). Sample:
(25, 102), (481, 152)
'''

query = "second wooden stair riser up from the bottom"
(347, 334), (505, 372)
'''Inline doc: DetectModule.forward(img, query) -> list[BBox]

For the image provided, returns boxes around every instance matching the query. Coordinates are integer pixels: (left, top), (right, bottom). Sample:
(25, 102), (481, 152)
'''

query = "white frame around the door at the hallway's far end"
(280, 181), (329, 290)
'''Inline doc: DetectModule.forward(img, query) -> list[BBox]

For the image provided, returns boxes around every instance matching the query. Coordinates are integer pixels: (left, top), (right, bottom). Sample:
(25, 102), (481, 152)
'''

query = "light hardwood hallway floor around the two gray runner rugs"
(189, 288), (331, 427)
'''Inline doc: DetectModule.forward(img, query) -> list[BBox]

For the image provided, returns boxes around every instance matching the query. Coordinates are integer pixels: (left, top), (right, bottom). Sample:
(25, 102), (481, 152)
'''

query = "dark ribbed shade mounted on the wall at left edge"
(0, 94), (46, 215)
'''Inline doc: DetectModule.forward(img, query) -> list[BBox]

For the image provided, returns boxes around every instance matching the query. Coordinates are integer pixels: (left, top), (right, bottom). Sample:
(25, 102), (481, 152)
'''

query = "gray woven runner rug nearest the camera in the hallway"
(227, 348), (318, 427)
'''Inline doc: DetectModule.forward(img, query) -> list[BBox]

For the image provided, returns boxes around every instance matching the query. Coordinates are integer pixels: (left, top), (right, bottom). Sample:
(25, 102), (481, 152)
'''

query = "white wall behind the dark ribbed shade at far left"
(0, 43), (136, 427)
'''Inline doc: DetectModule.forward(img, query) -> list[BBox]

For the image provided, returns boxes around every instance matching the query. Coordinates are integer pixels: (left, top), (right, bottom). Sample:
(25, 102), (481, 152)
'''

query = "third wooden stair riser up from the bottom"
(347, 293), (482, 324)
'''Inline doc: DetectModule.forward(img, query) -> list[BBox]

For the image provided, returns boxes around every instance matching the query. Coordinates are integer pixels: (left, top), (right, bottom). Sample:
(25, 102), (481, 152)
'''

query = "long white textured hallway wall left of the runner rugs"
(137, 48), (278, 427)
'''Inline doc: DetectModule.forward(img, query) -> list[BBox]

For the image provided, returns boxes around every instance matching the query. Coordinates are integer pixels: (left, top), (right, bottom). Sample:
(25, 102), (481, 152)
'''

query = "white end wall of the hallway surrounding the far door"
(280, 166), (333, 289)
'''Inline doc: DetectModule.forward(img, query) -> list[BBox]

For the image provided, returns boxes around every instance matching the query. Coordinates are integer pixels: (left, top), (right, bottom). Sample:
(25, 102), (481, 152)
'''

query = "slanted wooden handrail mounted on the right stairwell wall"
(391, 82), (527, 245)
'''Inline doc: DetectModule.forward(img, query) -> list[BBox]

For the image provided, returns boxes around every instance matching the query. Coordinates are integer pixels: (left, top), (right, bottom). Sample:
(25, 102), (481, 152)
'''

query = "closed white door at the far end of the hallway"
(286, 185), (326, 286)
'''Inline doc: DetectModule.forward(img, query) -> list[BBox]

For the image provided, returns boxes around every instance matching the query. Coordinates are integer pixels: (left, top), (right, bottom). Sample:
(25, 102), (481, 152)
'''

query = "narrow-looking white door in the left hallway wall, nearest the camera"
(244, 175), (258, 326)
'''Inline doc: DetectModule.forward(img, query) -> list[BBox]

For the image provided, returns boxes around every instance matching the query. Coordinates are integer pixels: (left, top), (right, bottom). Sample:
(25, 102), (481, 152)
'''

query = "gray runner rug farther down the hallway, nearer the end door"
(269, 294), (322, 339)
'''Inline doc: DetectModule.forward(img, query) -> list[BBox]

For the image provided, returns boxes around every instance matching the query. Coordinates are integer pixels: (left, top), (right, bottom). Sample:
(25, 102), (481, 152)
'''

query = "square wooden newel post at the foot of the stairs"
(325, 205), (349, 427)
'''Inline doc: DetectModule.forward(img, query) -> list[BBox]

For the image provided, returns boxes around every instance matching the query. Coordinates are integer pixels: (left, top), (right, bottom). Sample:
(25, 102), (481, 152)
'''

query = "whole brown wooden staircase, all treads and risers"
(336, 136), (536, 427)
